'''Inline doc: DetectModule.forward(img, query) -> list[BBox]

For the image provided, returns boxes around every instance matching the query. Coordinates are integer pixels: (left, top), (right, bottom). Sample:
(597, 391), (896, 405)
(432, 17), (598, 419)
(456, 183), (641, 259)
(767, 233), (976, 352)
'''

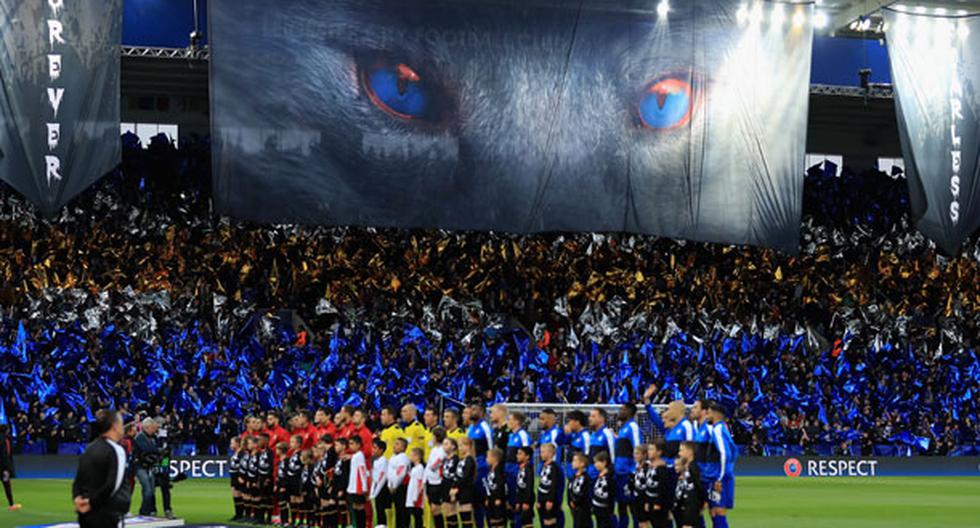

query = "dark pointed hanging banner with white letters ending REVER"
(0, 0), (122, 214)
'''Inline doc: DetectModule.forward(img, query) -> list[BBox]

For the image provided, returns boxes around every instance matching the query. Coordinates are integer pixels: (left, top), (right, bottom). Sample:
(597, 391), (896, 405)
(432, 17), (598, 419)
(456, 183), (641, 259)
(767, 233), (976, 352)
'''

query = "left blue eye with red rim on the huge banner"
(365, 64), (429, 119)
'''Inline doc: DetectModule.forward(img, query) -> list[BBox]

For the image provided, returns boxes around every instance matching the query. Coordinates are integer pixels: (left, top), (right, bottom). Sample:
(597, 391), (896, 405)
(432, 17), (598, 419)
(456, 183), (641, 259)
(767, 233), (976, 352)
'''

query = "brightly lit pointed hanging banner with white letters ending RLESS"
(885, 9), (980, 255)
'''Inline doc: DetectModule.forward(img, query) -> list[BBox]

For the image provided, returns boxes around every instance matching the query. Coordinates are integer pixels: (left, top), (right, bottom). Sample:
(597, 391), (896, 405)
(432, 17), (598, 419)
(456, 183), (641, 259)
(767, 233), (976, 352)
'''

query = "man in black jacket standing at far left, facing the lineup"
(72, 410), (130, 528)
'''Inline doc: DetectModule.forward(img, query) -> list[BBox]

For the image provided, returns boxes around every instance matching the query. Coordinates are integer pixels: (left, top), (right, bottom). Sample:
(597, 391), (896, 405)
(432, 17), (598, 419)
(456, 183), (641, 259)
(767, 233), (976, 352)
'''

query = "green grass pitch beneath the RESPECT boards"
(0, 477), (980, 528)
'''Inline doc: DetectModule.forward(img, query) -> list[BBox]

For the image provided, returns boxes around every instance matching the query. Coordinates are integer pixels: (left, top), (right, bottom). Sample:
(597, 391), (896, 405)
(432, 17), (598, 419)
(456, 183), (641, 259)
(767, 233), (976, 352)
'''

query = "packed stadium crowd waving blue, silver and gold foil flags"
(0, 137), (980, 454)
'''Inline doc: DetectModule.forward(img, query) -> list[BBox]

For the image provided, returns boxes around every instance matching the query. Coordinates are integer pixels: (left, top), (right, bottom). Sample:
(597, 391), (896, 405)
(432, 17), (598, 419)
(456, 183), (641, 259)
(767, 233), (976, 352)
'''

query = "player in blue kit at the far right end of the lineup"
(701, 401), (738, 528)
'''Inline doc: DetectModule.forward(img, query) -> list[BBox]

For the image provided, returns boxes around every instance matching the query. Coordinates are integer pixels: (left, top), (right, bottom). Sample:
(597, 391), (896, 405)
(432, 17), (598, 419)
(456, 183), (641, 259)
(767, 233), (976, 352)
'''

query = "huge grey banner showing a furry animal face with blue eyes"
(209, 0), (812, 251)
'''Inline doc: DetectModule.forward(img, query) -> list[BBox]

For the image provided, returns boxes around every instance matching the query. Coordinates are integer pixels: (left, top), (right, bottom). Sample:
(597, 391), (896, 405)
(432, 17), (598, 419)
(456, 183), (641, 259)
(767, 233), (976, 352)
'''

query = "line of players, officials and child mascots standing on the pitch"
(230, 387), (736, 528)
